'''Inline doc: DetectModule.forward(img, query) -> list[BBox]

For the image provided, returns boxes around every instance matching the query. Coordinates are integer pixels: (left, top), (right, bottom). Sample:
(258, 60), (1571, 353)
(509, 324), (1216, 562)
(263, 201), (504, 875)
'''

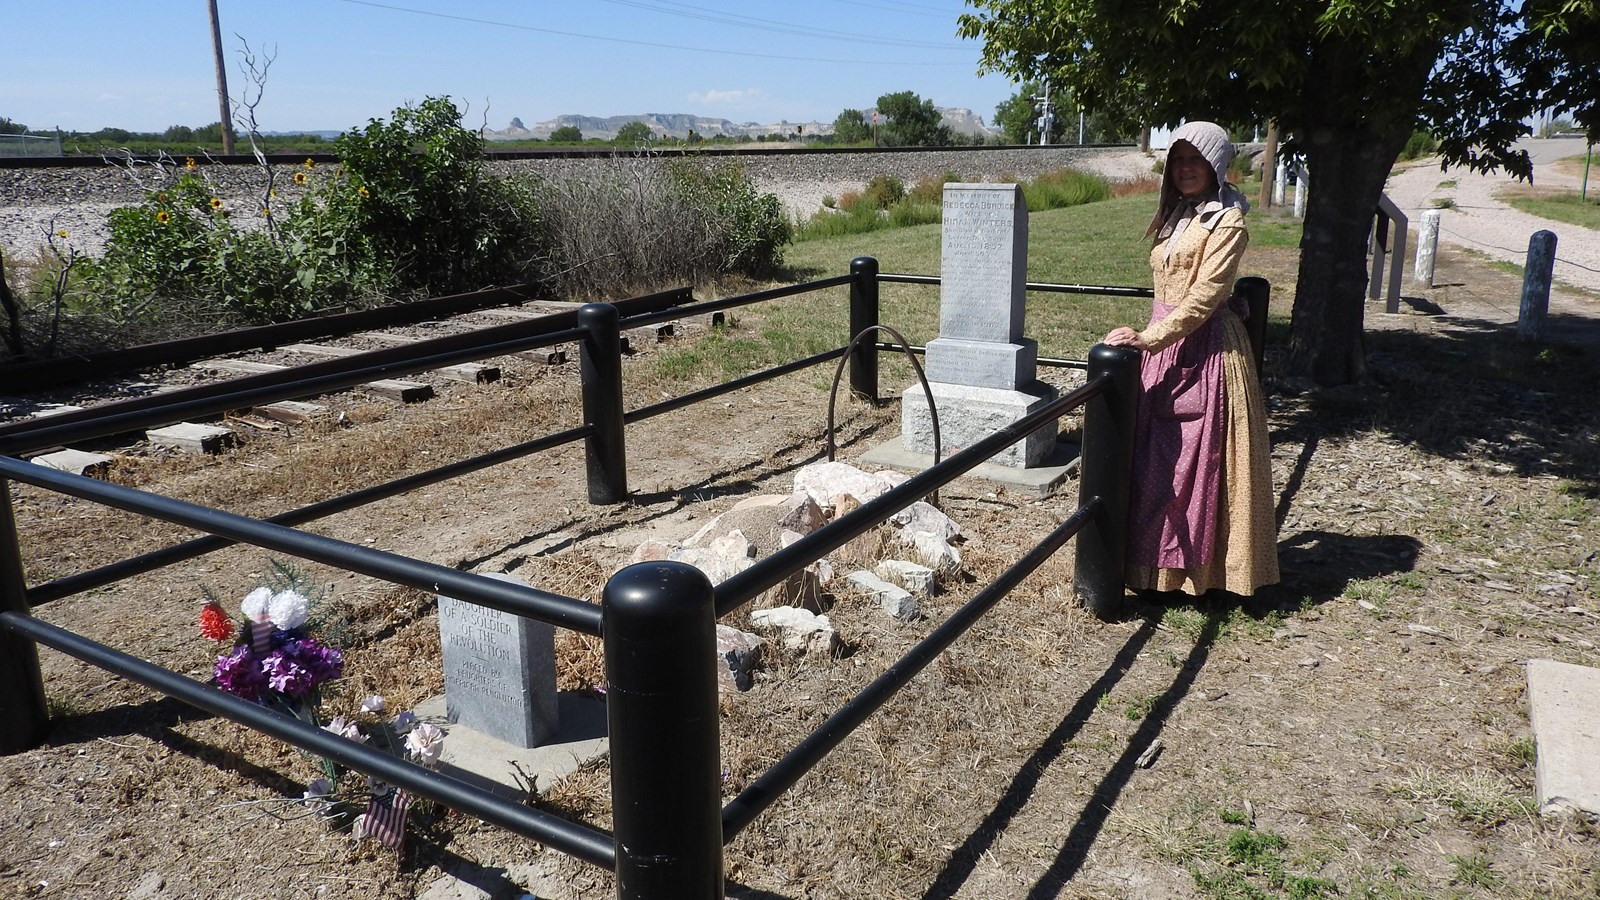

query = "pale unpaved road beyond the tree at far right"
(1382, 138), (1600, 291)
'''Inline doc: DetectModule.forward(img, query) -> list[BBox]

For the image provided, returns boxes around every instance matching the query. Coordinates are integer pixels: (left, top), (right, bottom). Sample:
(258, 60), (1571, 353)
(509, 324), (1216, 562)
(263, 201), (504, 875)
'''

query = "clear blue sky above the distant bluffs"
(0, 0), (1014, 131)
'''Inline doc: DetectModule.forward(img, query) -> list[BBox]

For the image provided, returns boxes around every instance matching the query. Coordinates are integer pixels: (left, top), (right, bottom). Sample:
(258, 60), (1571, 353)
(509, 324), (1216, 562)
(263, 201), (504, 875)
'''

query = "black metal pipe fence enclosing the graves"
(0, 258), (1266, 900)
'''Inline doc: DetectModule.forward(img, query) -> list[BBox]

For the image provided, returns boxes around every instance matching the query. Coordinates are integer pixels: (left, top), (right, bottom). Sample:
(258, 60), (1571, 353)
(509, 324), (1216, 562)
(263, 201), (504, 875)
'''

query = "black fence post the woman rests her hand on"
(1072, 344), (1139, 618)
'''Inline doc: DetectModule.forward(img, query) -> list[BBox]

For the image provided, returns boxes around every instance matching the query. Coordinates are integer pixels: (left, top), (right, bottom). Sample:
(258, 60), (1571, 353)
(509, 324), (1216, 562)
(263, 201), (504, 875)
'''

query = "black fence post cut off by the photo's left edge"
(0, 479), (50, 756)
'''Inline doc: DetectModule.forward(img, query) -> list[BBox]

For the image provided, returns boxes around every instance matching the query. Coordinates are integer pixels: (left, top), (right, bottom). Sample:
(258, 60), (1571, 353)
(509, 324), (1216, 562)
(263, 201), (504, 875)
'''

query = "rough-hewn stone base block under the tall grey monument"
(901, 381), (1059, 469)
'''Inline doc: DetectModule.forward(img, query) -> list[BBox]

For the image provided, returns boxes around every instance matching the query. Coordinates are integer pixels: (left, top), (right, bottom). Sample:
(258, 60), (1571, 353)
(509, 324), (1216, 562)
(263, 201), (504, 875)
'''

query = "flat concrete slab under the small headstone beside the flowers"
(416, 692), (611, 801)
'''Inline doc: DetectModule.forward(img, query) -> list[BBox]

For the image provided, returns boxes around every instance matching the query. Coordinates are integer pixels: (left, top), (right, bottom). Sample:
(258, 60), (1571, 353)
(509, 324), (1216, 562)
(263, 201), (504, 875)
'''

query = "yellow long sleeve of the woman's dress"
(1141, 210), (1250, 352)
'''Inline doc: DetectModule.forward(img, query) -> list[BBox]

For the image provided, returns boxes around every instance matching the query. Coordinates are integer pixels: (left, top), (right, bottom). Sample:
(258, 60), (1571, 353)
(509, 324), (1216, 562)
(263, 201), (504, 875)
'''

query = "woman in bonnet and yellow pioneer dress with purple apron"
(1106, 122), (1278, 594)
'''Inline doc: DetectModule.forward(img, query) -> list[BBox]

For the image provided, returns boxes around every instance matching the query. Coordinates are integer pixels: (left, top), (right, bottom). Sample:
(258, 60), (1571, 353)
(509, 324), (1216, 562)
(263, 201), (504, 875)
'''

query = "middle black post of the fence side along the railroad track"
(578, 303), (627, 504)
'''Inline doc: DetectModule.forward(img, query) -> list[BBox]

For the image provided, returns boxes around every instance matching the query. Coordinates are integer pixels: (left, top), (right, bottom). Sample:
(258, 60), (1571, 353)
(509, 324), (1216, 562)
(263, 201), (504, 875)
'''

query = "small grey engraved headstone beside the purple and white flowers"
(438, 573), (558, 748)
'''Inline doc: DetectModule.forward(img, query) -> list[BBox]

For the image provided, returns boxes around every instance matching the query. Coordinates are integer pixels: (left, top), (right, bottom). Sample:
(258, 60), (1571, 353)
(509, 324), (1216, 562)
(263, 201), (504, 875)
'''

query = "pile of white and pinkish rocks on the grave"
(630, 463), (962, 690)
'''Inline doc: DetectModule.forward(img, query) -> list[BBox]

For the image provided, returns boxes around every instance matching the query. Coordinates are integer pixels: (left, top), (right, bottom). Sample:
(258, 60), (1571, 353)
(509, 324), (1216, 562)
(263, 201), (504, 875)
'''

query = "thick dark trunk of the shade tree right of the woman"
(1288, 121), (1410, 386)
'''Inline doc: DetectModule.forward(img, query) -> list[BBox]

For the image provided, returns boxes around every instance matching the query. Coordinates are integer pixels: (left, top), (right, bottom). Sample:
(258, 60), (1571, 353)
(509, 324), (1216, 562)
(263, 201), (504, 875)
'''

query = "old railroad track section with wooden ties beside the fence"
(0, 285), (712, 476)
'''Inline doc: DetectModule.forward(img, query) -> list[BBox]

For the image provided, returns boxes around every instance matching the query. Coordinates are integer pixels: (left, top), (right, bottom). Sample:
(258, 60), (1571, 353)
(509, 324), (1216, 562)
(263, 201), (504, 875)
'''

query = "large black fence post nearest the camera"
(600, 562), (723, 900)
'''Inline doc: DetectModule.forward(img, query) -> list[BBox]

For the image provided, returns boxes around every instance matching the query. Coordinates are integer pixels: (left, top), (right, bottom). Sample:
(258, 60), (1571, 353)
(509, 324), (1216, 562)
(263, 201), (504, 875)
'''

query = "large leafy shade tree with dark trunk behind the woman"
(958, 0), (1600, 384)
